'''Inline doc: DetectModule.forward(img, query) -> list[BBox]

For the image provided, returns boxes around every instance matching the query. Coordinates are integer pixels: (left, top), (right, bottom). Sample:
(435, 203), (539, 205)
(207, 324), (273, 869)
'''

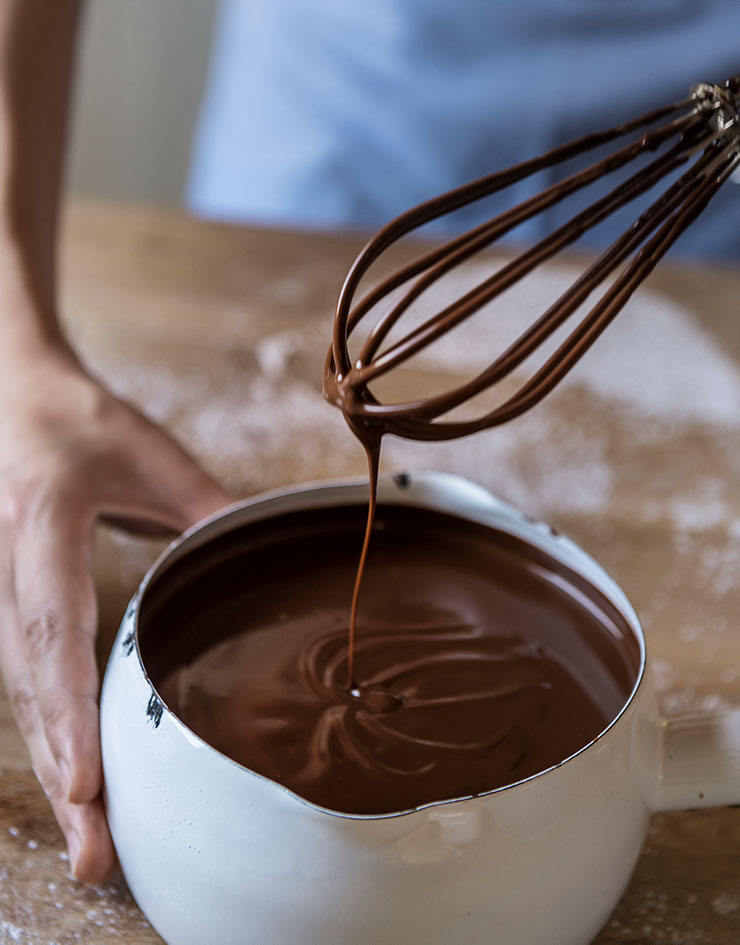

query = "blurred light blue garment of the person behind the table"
(188, 0), (740, 258)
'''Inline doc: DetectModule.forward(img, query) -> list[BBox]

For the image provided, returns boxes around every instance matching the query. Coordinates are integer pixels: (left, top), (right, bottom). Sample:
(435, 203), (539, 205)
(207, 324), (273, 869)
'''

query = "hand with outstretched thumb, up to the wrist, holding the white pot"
(0, 353), (229, 883)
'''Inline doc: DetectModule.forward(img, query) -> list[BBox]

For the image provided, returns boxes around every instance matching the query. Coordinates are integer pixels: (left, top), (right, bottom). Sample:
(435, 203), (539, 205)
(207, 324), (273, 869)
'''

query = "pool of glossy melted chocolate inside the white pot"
(139, 505), (639, 814)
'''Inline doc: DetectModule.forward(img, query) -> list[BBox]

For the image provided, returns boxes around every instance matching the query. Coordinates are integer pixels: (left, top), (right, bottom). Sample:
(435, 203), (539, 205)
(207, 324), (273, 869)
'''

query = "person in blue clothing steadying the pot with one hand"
(0, 0), (740, 883)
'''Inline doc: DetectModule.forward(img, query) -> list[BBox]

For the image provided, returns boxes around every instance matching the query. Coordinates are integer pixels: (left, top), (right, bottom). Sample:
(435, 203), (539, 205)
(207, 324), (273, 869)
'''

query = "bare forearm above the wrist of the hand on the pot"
(0, 0), (82, 360)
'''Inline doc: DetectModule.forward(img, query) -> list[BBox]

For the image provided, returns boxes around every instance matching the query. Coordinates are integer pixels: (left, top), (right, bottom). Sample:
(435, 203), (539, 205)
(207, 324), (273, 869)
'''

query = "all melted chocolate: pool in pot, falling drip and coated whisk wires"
(140, 80), (740, 814)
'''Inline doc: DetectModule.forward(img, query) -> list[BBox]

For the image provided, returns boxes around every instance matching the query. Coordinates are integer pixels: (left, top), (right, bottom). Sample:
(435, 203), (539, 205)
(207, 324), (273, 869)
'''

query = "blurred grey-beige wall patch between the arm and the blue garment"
(68, 0), (218, 205)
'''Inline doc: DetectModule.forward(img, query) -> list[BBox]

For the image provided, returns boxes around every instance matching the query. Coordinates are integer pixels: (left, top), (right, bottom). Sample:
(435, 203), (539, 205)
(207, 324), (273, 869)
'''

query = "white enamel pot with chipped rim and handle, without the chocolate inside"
(101, 472), (740, 945)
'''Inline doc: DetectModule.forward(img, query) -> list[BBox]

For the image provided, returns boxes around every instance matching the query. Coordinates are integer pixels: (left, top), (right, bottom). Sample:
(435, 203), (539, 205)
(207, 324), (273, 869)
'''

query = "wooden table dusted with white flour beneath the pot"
(0, 206), (740, 945)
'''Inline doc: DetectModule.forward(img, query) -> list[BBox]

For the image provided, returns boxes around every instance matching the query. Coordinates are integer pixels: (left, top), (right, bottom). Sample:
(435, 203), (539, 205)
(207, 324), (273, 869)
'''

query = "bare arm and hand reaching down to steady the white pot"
(0, 0), (227, 882)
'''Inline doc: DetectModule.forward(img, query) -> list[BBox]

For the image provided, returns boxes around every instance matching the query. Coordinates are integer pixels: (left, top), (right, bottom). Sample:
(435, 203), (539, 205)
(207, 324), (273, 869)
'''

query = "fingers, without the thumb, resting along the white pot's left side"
(0, 486), (115, 883)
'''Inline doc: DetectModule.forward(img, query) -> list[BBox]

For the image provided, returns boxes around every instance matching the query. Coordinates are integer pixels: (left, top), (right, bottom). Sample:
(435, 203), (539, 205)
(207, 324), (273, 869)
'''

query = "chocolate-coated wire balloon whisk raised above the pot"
(324, 75), (740, 440)
